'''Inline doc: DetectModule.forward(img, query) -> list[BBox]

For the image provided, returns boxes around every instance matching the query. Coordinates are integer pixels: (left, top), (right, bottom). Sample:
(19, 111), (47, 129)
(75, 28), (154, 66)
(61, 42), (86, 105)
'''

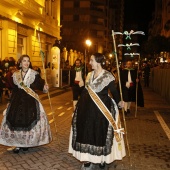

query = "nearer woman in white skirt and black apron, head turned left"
(69, 53), (126, 170)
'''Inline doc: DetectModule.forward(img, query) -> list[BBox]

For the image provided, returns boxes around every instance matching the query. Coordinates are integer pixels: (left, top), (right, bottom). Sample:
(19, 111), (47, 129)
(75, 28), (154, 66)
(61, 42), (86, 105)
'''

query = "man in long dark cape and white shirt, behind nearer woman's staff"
(120, 61), (144, 115)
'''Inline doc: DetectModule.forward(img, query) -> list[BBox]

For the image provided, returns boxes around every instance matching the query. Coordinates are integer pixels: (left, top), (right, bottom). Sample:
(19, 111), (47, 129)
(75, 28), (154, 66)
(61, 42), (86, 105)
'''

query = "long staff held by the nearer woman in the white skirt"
(112, 30), (130, 158)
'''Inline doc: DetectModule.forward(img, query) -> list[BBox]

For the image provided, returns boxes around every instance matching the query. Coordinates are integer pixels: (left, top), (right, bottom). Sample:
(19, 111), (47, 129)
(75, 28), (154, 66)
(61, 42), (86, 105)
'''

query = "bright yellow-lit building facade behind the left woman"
(0, 0), (61, 68)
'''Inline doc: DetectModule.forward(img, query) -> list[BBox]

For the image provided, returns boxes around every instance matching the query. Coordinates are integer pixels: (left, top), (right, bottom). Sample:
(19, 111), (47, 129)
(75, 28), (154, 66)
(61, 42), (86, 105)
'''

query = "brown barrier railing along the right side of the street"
(150, 68), (170, 103)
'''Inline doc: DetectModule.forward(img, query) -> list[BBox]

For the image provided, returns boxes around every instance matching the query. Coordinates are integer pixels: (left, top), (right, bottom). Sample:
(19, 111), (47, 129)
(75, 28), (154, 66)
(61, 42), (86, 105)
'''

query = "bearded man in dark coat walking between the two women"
(70, 59), (86, 109)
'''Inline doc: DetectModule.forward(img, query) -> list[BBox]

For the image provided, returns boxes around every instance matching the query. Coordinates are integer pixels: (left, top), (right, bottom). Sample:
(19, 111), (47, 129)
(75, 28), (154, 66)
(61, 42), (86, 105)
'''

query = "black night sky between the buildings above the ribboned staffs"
(124, 0), (155, 36)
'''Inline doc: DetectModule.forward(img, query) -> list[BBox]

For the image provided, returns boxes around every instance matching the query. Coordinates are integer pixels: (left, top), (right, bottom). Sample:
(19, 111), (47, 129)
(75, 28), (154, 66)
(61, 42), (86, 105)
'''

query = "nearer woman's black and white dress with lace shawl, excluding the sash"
(69, 70), (124, 163)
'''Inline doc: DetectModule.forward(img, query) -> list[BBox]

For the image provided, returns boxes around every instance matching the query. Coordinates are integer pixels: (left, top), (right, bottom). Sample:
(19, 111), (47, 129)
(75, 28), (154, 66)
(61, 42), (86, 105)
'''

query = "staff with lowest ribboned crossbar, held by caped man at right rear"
(124, 53), (140, 117)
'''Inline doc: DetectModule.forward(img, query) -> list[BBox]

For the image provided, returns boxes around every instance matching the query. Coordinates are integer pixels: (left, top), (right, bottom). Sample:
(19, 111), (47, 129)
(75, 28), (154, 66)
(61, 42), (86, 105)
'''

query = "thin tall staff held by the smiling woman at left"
(38, 33), (59, 142)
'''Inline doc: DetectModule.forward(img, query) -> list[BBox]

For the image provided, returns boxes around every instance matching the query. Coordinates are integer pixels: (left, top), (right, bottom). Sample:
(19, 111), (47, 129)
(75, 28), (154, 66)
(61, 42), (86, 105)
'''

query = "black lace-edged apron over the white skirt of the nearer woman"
(72, 89), (115, 155)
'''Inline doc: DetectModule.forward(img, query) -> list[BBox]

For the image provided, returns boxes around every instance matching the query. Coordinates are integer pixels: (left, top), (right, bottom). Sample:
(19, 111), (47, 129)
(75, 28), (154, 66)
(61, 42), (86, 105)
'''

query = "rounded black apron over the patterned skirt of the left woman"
(6, 88), (40, 131)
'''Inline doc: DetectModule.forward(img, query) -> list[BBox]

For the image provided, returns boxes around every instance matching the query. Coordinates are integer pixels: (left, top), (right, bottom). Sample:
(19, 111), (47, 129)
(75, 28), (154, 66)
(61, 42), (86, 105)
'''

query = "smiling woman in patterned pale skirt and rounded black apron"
(0, 55), (52, 153)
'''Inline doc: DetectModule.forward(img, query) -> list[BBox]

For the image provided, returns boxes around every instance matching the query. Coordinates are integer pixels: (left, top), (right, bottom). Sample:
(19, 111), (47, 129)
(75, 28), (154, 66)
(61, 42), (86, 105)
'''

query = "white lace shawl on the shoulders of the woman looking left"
(86, 70), (115, 92)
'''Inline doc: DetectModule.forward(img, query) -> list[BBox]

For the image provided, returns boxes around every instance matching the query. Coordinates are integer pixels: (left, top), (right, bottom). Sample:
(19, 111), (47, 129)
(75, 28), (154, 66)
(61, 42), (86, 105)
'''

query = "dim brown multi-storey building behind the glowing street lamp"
(61, 0), (124, 59)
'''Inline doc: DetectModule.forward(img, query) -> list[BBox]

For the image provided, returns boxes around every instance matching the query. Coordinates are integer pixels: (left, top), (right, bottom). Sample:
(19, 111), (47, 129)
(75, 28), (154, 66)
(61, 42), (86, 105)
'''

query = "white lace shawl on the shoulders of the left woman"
(13, 69), (38, 89)
